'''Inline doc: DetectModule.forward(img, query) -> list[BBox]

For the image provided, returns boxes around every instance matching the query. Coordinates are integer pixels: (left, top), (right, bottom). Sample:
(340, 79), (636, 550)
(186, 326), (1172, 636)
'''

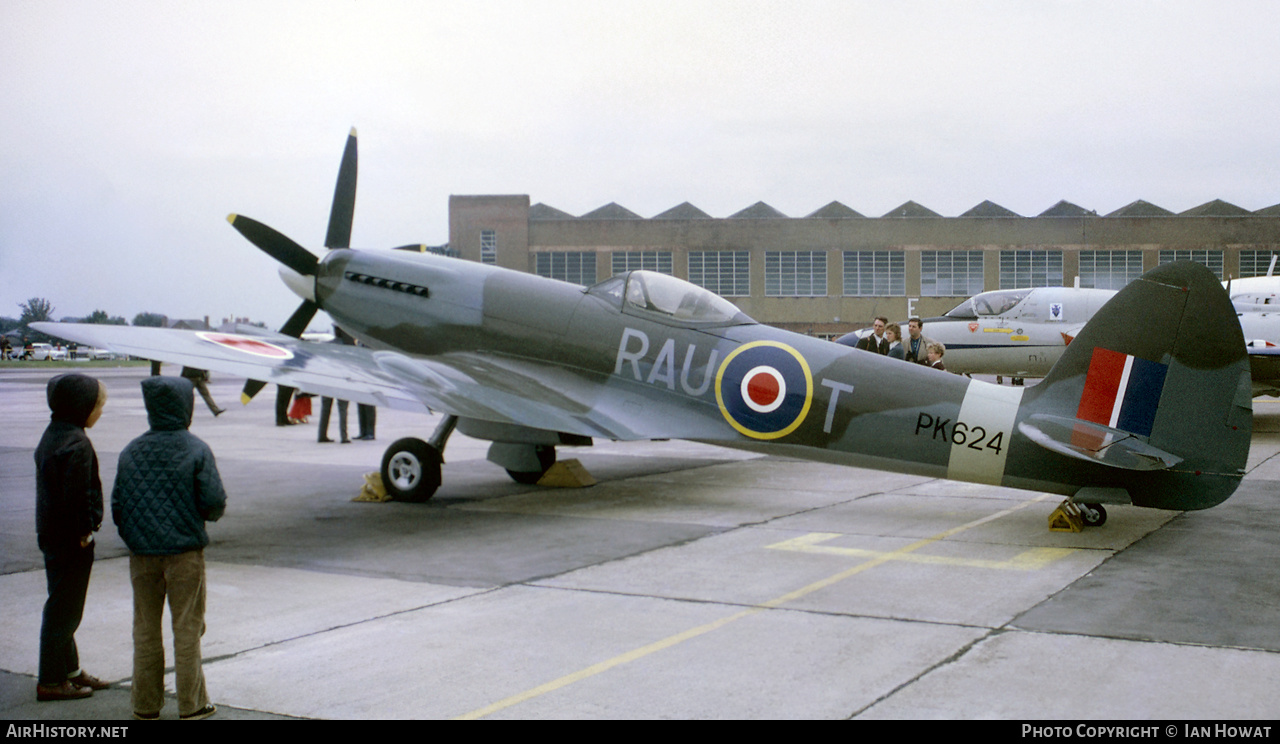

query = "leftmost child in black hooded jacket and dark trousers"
(36, 374), (108, 700)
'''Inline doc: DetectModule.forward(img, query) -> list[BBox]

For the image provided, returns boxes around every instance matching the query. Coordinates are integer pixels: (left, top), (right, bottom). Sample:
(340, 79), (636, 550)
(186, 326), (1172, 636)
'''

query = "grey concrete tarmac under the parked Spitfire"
(0, 366), (1280, 721)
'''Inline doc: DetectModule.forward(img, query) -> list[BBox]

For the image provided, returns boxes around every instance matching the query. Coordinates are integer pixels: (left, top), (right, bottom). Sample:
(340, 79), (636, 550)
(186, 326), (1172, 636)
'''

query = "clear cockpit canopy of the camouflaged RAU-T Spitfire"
(586, 270), (755, 325)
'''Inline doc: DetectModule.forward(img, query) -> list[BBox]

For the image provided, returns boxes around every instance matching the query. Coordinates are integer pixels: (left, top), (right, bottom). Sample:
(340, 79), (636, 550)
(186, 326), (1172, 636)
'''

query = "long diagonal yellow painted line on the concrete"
(454, 493), (1053, 721)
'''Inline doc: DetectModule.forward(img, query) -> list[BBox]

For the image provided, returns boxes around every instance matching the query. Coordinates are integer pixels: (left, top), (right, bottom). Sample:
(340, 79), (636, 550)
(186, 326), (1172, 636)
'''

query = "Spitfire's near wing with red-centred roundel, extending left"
(32, 323), (727, 441)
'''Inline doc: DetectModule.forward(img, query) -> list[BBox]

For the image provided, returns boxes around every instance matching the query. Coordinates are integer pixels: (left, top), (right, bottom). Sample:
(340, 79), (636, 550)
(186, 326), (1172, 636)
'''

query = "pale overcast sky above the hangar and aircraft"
(0, 0), (1280, 327)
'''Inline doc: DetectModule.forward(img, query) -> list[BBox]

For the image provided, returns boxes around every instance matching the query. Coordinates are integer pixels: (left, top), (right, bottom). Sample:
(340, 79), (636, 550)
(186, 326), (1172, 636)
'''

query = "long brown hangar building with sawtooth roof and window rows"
(449, 195), (1280, 337)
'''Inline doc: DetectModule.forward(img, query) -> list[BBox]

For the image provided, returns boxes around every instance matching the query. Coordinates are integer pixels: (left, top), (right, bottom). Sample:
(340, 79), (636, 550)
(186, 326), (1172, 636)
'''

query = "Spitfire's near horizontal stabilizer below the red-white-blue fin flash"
(1018, 414), (1183, 470)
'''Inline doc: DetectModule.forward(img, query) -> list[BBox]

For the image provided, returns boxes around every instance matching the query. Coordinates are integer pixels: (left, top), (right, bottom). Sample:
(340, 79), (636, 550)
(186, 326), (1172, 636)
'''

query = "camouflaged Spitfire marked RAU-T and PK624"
(40, 137), (1252, 524)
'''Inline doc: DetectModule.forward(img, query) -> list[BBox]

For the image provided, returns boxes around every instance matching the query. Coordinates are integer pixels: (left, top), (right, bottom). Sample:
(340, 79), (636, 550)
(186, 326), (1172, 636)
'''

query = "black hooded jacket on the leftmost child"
(36, 374), (102, 548)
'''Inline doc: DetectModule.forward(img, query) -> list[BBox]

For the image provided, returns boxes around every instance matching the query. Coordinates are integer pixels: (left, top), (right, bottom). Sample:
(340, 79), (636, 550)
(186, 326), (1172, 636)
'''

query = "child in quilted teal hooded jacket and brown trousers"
(111, 378), (227, 720)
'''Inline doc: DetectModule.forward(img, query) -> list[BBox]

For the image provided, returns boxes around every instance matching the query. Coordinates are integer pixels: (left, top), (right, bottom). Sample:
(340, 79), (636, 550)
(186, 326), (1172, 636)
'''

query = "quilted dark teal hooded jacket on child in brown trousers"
(111, 376), (227, 556)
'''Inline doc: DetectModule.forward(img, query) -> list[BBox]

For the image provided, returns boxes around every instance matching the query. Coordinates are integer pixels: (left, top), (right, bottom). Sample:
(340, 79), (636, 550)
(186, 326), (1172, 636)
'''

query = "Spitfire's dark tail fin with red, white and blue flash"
(1020, 261), (1253, 510)
